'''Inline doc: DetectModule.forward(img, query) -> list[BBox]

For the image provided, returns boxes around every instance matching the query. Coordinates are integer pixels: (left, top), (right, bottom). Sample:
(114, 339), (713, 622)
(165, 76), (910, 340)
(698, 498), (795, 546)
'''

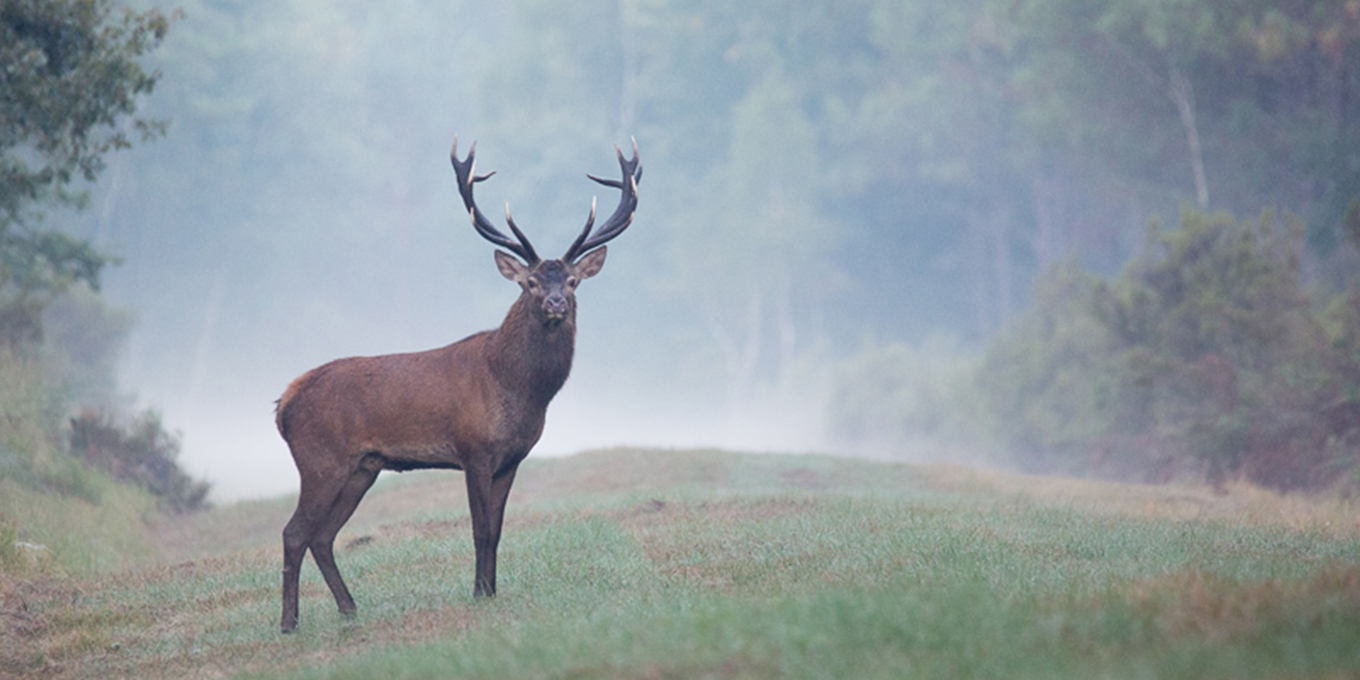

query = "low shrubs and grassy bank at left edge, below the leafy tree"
(0, 287), (208, 574)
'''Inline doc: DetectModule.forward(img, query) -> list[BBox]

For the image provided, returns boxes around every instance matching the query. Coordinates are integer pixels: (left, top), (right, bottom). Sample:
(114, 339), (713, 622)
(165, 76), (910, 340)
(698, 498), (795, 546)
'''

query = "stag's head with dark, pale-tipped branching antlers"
(449, 137), (642, 326)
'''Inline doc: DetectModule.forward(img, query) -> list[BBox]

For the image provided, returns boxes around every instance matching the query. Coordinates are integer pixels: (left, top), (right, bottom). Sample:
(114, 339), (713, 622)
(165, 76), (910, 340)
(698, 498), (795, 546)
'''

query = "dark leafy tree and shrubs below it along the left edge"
(0, 0), (209, 541)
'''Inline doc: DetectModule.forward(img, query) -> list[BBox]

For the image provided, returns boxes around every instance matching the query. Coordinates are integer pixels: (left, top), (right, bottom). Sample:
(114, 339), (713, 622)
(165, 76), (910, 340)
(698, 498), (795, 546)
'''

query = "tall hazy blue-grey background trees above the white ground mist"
(85, 0), (1360, 424)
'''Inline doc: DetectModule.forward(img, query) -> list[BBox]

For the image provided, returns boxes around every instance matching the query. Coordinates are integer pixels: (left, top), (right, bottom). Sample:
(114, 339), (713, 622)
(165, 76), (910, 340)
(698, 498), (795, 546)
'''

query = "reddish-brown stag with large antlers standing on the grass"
(275, 136), (642, 632)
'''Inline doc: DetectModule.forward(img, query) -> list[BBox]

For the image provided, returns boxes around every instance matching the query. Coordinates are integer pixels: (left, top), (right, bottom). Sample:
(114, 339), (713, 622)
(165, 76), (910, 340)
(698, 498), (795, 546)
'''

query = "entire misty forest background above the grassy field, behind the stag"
(0, 0), (1360, 505)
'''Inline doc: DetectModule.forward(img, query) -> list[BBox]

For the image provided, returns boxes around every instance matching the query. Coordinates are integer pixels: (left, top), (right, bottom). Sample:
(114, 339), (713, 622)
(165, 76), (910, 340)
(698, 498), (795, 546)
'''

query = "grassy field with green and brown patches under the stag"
(0, 450), (1360, 679)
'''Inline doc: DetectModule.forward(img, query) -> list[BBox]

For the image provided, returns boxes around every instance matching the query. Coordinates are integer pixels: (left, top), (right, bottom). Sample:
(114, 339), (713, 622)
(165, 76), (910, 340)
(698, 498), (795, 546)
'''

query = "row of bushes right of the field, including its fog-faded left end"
(836, 201), (1360, 494)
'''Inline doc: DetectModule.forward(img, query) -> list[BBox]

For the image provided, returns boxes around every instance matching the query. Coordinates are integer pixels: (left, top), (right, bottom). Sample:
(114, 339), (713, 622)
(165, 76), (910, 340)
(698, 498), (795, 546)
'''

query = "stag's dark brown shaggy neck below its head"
(487, 296), (577, 405)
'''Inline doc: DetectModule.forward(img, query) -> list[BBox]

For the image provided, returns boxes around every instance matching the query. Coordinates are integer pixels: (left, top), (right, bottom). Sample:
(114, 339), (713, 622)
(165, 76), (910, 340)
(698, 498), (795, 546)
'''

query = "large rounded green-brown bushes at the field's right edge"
(981, 209), (1357, 488)
